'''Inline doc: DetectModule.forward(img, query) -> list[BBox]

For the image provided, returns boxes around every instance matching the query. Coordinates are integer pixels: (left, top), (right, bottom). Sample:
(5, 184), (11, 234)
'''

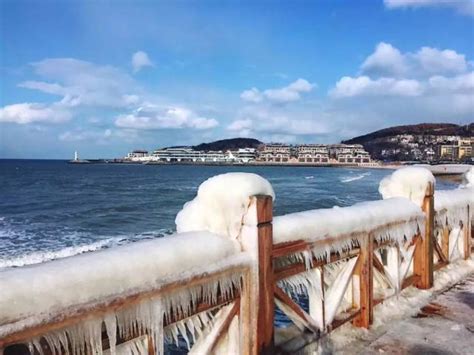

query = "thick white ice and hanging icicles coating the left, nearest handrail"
(0, 232), (249, 354)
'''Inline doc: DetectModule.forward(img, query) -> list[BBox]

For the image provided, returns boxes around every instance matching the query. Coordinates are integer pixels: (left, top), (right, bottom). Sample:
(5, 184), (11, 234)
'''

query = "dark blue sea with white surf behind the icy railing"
(0, 160), (457, 270)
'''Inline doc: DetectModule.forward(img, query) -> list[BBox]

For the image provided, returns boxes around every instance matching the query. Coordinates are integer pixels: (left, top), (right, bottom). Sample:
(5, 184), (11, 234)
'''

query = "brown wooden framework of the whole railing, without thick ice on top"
(0, 186), (471, 354)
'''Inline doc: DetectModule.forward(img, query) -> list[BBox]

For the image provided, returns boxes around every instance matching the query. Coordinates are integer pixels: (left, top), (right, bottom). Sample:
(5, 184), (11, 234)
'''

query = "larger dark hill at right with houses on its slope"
(342, 123), (474, 161)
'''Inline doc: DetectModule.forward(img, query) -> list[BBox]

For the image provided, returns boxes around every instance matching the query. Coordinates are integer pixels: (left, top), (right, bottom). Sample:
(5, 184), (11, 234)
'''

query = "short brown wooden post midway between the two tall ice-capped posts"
(352, 234), (374, 328)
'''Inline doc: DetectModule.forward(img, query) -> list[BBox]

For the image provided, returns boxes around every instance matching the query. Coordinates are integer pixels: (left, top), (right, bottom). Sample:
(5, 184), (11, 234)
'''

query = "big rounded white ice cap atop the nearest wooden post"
(176, 173), (275, 239)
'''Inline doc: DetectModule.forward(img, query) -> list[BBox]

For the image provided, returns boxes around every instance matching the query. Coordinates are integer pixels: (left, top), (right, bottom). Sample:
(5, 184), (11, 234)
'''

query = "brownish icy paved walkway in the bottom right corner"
(336, 274), (474, 355)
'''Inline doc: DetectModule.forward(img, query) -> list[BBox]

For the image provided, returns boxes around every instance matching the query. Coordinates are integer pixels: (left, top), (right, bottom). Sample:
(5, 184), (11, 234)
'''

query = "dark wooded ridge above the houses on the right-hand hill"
(342, 123), (474, 144)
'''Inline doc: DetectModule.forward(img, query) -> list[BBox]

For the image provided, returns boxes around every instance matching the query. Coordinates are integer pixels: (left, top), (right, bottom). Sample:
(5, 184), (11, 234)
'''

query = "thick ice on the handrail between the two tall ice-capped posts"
(273, 197), (424, 258)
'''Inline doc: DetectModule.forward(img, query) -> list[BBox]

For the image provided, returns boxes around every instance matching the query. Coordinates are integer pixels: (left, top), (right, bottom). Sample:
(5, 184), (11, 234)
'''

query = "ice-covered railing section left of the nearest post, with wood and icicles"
(0, 232), (249, 354)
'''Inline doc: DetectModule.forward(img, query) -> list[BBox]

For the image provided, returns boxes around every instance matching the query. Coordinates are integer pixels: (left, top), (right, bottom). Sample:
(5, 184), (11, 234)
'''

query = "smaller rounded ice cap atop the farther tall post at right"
(379, 166), (435, 206)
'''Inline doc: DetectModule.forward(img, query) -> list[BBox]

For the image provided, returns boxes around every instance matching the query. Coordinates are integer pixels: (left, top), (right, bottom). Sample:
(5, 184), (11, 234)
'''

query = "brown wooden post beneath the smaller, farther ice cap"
(413, 184), (434, 290)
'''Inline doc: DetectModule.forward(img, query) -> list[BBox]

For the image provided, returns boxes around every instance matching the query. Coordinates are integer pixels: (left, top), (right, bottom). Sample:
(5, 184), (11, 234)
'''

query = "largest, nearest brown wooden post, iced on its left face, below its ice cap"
(240, 196), (275, 355)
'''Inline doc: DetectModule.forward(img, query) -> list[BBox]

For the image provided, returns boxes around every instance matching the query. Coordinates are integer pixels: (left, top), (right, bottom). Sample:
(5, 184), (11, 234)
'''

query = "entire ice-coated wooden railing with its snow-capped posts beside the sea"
(0, 168), (472, 354)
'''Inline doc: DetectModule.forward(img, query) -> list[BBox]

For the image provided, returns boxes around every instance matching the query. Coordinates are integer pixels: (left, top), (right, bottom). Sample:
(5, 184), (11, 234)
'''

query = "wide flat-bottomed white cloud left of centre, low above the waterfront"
(115, 106), (219, 130)
